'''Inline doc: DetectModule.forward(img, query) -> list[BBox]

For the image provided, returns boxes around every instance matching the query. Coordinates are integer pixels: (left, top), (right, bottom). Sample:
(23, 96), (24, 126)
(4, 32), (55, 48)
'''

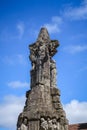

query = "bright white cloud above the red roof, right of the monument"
(64, 100), (87, 124)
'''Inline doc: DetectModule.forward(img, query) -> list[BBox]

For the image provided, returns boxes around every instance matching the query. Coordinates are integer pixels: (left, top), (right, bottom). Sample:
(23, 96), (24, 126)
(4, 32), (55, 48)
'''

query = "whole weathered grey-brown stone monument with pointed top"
(17, 28), (68, 130)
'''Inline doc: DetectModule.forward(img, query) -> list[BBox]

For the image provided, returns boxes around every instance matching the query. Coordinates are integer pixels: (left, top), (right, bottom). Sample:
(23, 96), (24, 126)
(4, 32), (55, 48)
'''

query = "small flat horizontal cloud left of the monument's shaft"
(7, 81), (29, 88)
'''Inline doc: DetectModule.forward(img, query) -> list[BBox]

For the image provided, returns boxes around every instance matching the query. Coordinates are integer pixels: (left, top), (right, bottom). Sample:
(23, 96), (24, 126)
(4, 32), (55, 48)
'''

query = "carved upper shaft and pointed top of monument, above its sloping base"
(29, 28), (59, 88)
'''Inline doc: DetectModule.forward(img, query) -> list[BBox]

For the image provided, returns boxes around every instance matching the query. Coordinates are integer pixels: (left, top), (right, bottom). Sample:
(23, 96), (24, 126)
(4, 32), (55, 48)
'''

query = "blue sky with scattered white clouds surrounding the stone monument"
(0, 0), (87, 130)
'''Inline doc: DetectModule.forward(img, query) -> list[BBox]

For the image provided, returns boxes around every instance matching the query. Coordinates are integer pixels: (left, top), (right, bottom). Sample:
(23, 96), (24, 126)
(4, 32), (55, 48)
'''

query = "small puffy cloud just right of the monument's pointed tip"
(44, 16), (62, 33)
